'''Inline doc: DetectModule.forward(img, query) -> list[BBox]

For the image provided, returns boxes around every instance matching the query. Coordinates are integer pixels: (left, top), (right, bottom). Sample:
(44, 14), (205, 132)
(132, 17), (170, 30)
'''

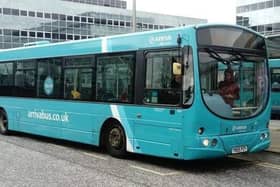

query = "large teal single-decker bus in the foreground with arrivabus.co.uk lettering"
(0, 24), (271, 160)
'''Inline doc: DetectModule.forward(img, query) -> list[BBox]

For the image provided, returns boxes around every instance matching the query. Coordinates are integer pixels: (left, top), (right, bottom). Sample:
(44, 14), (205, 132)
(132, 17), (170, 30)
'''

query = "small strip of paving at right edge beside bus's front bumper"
(267, 120), (280, 153)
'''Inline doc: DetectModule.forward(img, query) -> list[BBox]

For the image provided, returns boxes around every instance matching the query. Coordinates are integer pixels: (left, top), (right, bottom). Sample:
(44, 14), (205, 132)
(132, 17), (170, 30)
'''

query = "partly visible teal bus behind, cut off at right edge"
(267, 34), (280, 119)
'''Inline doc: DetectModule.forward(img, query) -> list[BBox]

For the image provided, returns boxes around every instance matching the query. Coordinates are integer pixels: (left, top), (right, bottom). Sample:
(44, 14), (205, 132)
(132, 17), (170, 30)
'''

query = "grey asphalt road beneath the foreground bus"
(0, 126), (280, 187)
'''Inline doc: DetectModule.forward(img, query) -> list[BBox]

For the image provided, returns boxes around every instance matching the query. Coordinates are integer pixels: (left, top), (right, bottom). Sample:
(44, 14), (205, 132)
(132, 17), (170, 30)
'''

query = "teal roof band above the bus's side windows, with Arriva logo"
(0, 24), (259, 62)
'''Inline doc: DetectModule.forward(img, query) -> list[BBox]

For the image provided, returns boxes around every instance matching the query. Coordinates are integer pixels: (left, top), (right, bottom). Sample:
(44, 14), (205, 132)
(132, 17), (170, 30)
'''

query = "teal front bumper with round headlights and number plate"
(183, 130), (271, 160)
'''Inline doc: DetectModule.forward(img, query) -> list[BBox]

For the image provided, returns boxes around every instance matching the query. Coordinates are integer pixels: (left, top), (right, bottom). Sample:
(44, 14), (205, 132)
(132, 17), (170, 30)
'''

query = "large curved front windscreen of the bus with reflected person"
(200, 49), (268, 118)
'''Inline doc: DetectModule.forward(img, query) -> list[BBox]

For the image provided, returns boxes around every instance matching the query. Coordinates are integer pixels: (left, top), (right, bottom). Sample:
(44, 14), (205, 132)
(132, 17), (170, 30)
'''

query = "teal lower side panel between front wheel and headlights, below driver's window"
(134, 107), (183, 158)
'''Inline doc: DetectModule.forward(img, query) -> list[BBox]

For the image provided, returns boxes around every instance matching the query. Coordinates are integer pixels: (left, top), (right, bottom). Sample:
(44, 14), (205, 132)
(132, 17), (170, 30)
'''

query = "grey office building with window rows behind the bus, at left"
(0, 0), (207, 49)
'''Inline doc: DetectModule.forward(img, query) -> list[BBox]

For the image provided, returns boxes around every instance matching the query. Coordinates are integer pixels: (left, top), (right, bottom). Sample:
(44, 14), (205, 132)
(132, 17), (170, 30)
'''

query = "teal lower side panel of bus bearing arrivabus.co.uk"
(1, 98), (100, 144)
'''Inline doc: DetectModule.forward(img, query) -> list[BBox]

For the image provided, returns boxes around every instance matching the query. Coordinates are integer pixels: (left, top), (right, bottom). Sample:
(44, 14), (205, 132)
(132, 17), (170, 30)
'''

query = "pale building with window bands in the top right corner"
(236, 0), (280, 35)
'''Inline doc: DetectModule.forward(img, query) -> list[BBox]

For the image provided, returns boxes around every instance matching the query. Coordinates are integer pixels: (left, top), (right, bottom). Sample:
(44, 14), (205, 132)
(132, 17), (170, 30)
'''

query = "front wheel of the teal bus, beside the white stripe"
(104, 121), (126, 158)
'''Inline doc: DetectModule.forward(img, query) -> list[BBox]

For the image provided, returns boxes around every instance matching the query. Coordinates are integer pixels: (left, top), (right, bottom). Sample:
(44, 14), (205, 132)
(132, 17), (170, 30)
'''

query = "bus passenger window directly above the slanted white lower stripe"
(96, 54), (135, 103)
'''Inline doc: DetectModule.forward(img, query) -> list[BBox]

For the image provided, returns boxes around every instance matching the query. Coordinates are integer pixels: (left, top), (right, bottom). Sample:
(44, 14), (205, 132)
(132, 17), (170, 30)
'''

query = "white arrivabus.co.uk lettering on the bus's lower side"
(27, 110), (69, 123)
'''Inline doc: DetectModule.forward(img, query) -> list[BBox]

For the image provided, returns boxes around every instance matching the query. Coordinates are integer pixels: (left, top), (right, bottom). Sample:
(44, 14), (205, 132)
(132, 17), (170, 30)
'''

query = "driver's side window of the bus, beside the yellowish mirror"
(144, 50), (182, 105)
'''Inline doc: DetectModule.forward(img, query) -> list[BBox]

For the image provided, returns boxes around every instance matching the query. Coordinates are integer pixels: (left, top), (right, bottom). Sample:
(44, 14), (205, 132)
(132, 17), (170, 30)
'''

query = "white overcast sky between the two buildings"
(127, 0), (236, 24)
